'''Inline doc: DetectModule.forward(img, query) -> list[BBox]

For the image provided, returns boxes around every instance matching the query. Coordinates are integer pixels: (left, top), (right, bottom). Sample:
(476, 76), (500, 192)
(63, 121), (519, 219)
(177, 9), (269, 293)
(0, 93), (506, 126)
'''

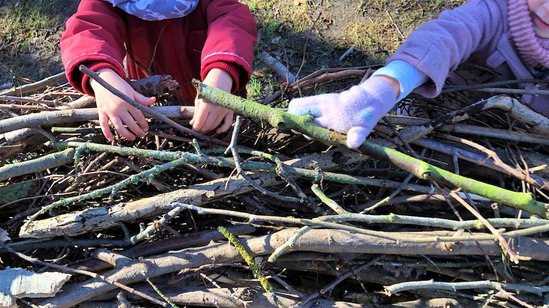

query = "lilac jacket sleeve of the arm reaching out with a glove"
(388, 0), (507, 97)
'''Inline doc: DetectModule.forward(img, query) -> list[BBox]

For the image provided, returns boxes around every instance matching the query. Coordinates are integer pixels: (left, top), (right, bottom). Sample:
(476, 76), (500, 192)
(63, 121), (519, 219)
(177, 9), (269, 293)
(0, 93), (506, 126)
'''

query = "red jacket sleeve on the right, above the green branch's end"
(200, 0), (257, 93)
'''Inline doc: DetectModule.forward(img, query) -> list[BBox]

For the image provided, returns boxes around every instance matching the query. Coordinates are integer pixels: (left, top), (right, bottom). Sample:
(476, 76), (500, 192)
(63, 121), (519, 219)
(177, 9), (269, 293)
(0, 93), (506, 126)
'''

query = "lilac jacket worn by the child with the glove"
(388, 0), (549, 116)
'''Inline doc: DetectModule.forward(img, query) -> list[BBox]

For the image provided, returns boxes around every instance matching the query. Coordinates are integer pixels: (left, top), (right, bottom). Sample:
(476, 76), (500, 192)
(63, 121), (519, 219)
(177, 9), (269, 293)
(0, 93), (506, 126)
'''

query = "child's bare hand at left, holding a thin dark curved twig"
(90, 68), (156, 141)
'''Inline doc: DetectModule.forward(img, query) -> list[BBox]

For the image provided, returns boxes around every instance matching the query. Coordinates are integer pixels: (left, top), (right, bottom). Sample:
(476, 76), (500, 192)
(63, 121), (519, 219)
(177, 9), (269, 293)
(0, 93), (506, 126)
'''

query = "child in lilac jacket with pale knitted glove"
(288, 0), (549, 148)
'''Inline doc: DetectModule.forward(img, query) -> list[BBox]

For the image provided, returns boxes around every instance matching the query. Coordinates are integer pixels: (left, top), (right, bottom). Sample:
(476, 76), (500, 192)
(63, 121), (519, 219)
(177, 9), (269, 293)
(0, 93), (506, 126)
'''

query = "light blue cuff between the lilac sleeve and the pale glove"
(372, 60), (428, 102)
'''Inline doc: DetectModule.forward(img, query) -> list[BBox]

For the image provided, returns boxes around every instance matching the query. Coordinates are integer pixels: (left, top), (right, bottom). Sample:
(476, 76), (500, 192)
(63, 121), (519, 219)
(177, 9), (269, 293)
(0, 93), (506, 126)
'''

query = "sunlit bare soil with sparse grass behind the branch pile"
(0, 0), (460, 88)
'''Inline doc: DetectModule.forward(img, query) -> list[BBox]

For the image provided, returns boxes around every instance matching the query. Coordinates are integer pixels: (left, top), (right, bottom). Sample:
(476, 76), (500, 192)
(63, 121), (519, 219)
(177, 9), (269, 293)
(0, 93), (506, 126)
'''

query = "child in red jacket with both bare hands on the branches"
(61, 0), (257, 141)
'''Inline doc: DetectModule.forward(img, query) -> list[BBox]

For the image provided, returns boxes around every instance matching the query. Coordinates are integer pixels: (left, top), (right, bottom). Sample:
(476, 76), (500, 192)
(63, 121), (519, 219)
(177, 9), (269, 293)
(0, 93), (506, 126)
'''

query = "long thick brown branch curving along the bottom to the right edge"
(40, 229), (549, 307)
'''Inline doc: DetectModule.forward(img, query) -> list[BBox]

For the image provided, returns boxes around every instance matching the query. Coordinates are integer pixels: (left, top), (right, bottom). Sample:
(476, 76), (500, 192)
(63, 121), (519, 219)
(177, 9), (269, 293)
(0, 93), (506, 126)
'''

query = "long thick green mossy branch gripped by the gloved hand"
(194, 81), (549, 218)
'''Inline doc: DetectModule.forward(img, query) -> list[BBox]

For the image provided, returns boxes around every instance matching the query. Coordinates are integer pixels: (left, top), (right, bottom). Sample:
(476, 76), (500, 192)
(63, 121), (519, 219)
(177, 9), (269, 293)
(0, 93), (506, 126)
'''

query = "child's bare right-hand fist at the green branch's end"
(190, 68), (234, 133)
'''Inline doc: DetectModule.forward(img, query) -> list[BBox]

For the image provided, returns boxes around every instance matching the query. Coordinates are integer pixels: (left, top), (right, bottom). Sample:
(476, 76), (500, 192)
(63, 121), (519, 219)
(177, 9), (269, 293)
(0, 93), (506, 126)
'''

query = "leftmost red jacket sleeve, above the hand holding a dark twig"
(61, 0), (126, 94)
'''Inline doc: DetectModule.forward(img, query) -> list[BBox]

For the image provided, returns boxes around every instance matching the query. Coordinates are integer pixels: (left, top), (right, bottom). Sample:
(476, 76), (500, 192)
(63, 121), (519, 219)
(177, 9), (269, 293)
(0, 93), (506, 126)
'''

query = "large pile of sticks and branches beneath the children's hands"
(0, 68), (549, 307)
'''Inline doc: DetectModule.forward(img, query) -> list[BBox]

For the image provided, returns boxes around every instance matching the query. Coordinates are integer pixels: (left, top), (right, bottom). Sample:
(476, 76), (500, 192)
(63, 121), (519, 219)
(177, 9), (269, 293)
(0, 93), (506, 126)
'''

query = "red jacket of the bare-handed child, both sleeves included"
(61, 0), (257, 105)
